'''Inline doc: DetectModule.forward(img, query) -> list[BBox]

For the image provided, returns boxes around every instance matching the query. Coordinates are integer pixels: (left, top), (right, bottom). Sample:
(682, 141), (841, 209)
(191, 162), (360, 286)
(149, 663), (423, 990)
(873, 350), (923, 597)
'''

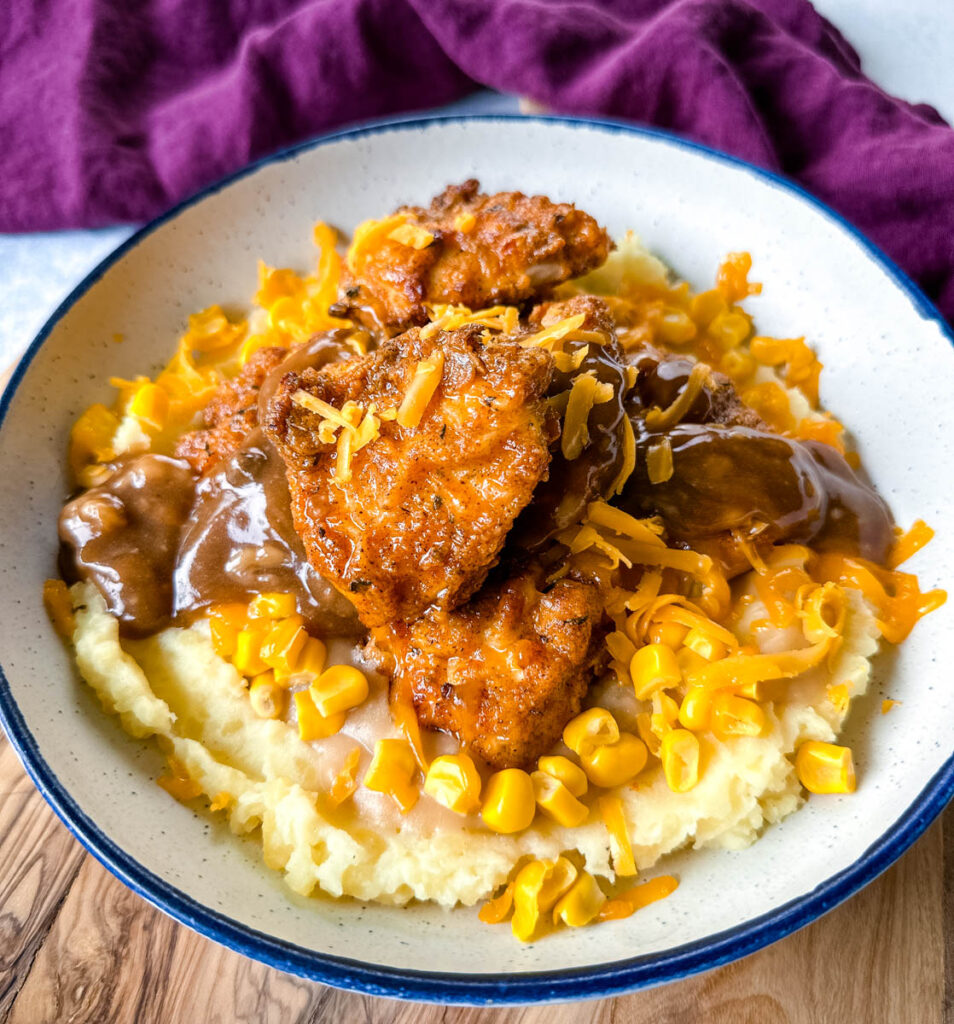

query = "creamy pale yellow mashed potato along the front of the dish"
(65, 584), (878, 907)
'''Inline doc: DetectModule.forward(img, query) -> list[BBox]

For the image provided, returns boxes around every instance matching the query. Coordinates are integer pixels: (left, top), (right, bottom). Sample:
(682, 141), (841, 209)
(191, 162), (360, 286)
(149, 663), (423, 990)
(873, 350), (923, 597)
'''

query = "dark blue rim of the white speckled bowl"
(0, 114), (954, 1006)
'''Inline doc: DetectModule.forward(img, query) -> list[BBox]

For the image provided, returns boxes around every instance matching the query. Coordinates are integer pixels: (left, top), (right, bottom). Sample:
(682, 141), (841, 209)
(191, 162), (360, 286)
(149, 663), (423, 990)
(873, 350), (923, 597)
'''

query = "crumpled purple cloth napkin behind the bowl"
(0, 0), (954, 322)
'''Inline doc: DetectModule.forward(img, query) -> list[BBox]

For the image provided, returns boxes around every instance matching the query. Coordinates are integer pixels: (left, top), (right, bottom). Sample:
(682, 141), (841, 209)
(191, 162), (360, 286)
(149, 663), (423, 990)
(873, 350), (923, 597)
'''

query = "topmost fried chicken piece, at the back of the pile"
(334, 179), (610, 335)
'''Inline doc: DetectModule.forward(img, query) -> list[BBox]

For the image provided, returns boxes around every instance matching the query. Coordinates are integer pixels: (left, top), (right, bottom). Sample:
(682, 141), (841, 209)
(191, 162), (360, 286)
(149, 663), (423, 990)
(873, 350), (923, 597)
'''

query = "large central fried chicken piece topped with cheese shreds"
(265, 326), (554, 627)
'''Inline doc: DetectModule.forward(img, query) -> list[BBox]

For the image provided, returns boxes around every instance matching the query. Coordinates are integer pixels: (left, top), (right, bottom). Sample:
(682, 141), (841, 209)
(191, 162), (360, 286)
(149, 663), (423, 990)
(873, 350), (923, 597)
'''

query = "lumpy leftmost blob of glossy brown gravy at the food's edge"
(59, 455), (194, 637)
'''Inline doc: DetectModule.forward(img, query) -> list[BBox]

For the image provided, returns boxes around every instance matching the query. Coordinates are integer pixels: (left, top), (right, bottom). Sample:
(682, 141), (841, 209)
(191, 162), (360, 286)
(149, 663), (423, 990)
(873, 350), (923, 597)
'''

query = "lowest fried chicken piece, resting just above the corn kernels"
(372, 571), (604, 769)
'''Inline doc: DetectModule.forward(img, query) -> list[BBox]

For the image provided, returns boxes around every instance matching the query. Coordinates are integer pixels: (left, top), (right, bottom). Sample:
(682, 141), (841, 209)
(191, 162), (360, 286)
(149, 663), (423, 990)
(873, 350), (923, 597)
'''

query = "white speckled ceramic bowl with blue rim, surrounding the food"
(0, 118), (954, 1002)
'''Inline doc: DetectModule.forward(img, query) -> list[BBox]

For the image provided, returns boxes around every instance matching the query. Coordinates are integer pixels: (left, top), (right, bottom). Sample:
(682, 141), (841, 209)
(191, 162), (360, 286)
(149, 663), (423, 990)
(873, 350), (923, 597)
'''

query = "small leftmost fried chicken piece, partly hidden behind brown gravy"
(175, 347), (288, 474)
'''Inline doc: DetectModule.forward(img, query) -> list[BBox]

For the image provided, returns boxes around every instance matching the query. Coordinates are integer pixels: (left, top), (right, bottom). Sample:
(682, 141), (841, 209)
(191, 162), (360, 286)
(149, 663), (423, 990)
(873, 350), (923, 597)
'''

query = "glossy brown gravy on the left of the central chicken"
(59, 331), (363, 637)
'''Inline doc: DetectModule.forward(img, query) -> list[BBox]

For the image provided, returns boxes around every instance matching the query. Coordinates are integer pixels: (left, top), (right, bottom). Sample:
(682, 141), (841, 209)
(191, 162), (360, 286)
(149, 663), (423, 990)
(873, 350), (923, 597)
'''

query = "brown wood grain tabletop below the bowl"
(0, 740), (954, 1024)
